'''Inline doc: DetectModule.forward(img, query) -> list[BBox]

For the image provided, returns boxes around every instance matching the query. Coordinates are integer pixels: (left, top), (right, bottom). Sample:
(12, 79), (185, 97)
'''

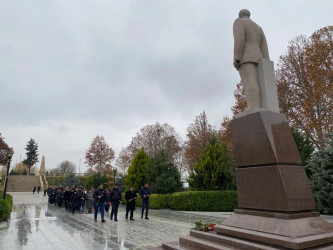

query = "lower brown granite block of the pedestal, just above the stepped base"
(236, 165), (315, 212)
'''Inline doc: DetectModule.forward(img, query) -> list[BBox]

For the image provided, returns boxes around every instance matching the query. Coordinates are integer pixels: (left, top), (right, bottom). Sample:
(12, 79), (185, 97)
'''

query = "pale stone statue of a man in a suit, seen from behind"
(233, 9), (269, 109)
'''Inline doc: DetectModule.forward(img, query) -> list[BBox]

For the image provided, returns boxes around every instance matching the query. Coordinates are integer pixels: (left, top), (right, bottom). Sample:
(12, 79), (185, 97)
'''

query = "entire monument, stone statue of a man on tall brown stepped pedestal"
(163, 10), (333, 250)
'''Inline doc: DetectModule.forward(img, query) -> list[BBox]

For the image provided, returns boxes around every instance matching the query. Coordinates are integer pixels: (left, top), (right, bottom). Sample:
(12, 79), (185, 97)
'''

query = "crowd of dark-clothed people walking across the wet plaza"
(44, 184), (151, 222)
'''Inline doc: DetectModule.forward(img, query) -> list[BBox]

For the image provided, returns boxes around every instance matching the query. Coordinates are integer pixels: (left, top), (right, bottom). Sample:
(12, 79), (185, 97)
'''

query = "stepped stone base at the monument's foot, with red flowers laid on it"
(162, 209), (333, 250)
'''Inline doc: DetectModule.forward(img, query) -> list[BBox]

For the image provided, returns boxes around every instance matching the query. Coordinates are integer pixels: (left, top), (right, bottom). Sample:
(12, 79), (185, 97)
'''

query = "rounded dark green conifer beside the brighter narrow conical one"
(147, 150), (182, 194)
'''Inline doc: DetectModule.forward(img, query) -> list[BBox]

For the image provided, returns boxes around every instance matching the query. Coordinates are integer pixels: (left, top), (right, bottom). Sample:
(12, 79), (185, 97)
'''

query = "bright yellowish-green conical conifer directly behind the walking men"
(125, 148), (150, 192)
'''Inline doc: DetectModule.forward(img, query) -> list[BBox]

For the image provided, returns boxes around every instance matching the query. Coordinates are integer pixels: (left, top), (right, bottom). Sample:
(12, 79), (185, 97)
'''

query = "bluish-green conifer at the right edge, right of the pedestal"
(307, 133), (333, 214)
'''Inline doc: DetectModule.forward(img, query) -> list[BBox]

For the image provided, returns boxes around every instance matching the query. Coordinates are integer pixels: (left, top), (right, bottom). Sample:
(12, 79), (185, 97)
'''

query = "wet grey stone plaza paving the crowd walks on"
(0, 193), (333, 250)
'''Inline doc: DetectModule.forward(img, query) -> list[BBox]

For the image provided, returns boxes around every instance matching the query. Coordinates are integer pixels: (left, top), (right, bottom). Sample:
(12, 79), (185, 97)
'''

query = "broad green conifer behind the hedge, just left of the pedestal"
(188, 137), (235, 190)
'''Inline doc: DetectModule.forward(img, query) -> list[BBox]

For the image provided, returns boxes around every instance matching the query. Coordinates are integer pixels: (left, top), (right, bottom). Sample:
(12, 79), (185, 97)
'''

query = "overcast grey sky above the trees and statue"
(0, 0), (333, 172)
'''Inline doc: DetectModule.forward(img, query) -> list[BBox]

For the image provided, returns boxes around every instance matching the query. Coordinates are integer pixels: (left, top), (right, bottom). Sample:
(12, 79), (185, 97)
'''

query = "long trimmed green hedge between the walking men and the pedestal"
(123, 190), (237, 212)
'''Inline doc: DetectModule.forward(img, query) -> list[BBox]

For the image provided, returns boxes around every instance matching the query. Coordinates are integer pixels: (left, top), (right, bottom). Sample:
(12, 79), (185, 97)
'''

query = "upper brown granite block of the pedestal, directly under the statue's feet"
(231, 111), (301, 167)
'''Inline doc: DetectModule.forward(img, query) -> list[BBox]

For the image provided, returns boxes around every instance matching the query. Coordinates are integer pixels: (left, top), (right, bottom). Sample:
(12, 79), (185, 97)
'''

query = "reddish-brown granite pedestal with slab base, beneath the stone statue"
(215, 111), (333, 249)
